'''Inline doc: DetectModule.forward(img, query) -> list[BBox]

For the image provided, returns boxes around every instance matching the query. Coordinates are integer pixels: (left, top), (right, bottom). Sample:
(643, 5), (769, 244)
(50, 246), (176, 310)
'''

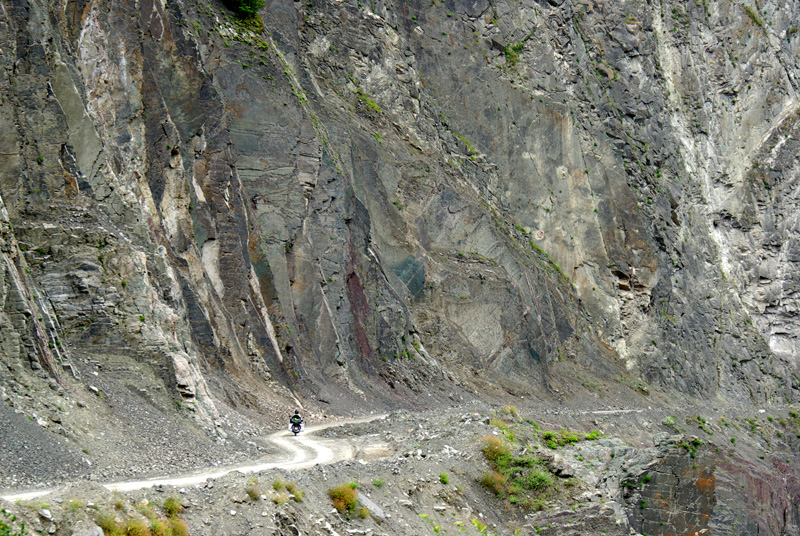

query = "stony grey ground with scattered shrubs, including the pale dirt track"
(3, 403), (796, 536)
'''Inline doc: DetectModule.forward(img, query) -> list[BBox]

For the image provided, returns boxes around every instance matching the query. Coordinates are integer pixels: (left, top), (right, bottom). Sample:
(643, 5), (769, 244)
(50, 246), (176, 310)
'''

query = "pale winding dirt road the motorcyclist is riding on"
(0, 415), (386, 502)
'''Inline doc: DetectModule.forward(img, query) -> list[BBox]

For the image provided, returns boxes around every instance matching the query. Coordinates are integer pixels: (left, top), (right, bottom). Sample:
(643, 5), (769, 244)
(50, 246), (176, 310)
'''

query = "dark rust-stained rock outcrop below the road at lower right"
(607, 436), (800, 536)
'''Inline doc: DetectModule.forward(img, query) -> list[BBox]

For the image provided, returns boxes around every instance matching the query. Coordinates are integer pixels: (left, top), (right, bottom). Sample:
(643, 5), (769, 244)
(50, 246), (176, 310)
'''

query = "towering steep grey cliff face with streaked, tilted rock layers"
(0, 0), (800, 440)
